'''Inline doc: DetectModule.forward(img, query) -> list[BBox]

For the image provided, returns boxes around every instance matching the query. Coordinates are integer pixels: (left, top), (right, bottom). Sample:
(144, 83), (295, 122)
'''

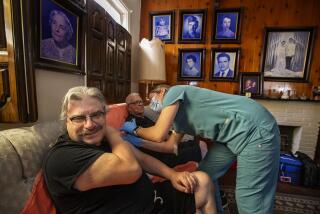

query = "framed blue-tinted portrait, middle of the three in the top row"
(179, 9), (207, 43)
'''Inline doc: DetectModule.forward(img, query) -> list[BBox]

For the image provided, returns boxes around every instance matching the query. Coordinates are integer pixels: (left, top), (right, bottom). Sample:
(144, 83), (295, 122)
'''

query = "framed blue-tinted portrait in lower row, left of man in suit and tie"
(178, 49), (205, 80)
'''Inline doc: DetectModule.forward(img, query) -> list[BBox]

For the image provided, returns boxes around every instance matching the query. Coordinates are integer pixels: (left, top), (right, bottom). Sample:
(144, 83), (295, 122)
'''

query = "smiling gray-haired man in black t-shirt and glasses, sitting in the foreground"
(43, 86), (215, 214)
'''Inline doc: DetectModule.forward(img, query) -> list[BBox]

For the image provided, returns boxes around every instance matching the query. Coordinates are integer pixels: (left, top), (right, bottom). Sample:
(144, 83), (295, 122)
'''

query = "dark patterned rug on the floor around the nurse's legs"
(221, 186), (320, 214)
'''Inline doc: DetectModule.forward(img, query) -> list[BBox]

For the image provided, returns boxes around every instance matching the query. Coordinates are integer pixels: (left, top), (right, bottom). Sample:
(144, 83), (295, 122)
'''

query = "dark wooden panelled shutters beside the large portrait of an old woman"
(87, 1), (131, 103)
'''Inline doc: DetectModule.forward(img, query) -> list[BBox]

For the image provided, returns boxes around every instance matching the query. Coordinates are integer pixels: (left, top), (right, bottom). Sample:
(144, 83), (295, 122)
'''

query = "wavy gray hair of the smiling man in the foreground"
(60, 86), (107, 120)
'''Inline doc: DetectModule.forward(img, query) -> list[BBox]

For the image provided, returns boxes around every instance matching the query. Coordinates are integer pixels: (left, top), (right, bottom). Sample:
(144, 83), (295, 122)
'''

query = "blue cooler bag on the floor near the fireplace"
(279, 154), (302, 185)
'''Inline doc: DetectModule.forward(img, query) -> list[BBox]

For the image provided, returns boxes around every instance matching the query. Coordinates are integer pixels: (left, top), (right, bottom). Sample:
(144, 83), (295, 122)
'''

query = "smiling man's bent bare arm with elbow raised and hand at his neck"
(74, 127), (142, 191)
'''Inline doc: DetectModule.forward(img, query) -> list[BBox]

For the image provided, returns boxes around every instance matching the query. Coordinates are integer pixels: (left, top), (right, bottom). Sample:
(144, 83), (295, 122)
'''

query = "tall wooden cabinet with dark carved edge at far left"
(0, 0), (37, 123)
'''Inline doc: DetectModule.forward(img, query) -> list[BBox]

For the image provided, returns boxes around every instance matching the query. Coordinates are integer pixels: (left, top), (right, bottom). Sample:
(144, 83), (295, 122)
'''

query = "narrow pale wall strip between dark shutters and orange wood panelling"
(123, 0), (141, 92)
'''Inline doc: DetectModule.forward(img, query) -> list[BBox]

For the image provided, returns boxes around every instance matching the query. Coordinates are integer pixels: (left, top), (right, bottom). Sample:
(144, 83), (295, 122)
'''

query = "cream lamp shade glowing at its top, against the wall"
(139, 38), (166, 82)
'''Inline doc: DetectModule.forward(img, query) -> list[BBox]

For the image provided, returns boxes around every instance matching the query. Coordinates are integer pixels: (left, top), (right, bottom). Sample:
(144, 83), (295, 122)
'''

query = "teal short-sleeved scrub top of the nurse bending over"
(163, 85), (277, 153)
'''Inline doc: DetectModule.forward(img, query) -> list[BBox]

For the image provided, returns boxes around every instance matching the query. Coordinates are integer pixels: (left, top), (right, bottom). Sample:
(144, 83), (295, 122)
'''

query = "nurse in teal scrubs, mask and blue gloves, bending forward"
(122, 85), (280, 214)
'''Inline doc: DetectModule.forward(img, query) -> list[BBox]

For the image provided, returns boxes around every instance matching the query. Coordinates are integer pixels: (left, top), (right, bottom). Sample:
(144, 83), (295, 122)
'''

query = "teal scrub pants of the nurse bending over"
(199, 126), (280, 214)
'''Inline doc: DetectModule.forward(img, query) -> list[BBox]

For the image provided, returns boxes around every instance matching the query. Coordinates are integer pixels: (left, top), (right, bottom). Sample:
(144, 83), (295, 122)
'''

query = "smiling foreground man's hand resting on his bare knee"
(170, 171), (199, 193)
